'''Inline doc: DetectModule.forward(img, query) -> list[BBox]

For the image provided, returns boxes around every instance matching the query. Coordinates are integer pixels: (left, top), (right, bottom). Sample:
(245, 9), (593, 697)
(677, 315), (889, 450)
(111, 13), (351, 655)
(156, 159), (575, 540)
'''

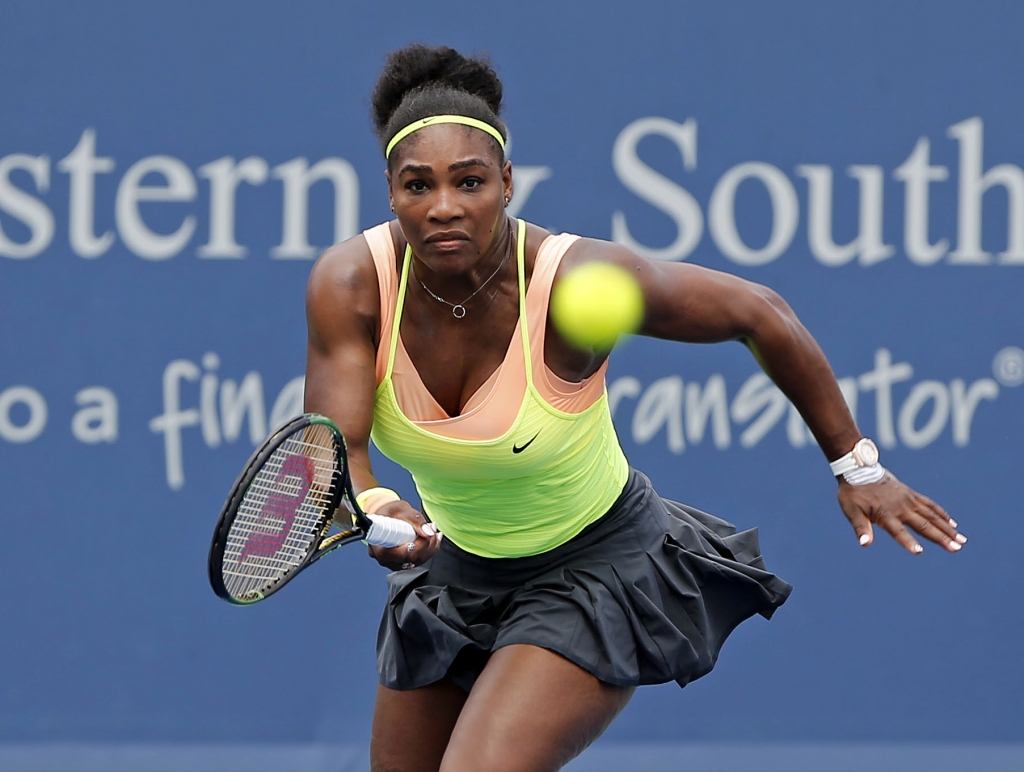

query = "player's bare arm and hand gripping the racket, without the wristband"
(304, 235), (438, 568)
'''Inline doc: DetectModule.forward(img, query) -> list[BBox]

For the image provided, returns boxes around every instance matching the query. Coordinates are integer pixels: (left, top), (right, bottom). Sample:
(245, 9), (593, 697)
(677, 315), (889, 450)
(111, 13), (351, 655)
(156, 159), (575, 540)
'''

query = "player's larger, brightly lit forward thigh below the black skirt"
(440, 644), (634, 772)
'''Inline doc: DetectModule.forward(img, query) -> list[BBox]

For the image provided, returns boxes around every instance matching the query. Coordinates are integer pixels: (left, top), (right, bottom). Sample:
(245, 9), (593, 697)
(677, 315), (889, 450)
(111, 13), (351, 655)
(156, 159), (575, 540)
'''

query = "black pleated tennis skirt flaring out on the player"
(377, 470), (793, 691)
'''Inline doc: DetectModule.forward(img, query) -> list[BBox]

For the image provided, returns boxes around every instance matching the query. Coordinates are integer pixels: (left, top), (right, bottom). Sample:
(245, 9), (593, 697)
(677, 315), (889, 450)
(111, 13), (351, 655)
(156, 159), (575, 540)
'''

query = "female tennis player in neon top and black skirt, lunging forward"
(305, 46), (967, 772)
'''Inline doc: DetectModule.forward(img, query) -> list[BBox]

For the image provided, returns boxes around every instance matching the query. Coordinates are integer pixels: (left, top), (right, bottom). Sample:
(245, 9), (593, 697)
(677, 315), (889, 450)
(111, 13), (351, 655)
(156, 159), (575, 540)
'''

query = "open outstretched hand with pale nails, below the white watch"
(839, 471), (967, 555)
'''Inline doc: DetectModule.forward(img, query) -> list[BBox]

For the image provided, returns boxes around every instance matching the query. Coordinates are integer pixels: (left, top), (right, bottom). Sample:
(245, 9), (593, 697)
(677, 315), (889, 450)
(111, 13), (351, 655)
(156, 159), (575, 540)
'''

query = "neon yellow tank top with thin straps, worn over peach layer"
(368, 220), (629, 557)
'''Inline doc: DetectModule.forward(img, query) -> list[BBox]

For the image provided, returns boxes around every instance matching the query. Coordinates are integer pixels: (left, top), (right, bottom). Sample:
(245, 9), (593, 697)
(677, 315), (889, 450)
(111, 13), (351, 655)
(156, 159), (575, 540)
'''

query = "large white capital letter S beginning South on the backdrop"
(611, 118), (703, 260)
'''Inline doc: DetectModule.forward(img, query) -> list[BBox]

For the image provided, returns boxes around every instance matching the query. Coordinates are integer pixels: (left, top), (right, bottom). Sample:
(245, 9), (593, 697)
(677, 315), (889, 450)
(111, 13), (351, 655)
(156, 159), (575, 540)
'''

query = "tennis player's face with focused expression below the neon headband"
(388, 124), (512, 273)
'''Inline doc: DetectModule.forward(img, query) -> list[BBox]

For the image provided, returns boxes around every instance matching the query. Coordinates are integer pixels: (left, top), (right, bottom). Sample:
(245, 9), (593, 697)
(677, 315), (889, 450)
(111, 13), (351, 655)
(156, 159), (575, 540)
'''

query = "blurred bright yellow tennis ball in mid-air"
(551, 262), (643, 351)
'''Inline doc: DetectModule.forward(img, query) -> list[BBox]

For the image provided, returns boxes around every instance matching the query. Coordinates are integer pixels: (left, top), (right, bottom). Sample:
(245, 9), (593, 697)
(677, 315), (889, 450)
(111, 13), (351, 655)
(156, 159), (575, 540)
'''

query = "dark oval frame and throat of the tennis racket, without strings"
(207, 413), (372, 606)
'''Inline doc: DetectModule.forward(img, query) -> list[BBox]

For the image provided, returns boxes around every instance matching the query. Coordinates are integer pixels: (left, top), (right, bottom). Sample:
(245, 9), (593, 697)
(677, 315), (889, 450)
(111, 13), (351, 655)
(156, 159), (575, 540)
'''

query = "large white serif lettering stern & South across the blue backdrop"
(6, 116), (1024, 268)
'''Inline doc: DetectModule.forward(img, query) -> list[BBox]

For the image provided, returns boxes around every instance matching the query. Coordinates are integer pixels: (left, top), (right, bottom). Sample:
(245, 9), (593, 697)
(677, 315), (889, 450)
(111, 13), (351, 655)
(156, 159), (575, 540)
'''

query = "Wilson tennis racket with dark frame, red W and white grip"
(209, 413), (417, 605)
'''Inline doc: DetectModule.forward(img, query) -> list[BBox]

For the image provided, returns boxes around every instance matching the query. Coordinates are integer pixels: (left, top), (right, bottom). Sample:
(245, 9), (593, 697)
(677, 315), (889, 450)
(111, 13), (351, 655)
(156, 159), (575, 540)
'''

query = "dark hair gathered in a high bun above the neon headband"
(373, 44), (508, 162)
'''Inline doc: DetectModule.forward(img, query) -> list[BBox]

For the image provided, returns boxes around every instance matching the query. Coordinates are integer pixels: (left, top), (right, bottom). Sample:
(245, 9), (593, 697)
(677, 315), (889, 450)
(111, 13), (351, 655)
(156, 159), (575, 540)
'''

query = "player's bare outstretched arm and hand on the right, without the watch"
(560, 242), (967, 553)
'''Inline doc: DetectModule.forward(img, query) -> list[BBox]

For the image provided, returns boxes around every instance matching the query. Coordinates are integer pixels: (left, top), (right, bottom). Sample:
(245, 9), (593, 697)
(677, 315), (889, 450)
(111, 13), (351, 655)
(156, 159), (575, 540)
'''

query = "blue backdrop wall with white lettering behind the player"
(0, 0), (1024, 769)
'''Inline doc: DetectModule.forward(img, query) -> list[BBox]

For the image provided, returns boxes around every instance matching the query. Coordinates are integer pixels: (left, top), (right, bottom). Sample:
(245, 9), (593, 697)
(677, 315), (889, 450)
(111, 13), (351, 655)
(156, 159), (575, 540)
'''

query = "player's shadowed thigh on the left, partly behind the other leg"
(370, 680), (468, 772)
